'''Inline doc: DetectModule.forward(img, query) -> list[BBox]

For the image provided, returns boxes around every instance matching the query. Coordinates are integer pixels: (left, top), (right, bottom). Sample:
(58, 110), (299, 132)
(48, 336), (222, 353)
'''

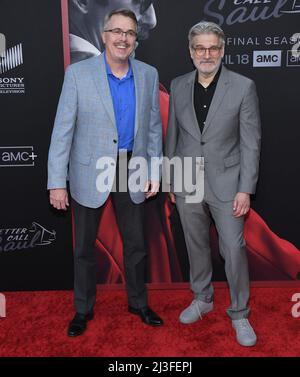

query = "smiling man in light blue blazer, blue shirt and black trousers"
(48, 9), (163, 336)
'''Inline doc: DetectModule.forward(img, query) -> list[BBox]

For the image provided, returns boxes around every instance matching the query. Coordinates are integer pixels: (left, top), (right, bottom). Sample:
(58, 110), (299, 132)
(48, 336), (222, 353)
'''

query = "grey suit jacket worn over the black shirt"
(165, 66), (261, 201)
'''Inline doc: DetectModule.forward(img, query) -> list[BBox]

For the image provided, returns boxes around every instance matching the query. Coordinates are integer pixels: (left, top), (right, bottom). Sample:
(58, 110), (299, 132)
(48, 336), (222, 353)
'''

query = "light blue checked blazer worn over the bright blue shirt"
(48, 55), (162, 208)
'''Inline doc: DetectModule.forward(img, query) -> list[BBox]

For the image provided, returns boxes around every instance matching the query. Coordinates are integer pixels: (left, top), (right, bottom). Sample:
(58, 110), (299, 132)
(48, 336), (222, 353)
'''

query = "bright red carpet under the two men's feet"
(0, 284), (300, 357)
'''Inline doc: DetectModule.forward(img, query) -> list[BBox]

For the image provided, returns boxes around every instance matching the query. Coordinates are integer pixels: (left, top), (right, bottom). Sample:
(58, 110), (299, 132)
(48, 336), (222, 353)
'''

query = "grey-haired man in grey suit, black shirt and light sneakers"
(165, 22), (261, 346)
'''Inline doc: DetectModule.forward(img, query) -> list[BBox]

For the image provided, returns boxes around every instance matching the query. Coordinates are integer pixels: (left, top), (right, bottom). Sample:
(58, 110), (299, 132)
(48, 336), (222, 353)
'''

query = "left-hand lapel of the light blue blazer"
(93, 54), (116, 127)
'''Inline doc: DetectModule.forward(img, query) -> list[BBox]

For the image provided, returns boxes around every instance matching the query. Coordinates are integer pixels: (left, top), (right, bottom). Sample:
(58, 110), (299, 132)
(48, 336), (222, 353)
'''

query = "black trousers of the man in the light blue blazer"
(72, 160), (147, 314)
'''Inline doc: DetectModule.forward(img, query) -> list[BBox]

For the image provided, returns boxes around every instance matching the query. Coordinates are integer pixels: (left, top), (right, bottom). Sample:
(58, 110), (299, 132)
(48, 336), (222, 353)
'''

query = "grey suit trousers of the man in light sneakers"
(176, 179), (250, 319)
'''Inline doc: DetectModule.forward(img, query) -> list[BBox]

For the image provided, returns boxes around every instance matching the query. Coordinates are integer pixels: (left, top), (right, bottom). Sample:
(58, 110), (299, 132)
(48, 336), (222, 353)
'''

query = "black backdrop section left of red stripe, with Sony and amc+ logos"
(0, 0), (73, 291)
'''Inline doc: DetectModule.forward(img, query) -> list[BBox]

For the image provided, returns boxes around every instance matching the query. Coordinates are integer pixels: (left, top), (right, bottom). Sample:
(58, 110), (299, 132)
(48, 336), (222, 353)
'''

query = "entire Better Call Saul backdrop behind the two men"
(0, 0), (300, 291)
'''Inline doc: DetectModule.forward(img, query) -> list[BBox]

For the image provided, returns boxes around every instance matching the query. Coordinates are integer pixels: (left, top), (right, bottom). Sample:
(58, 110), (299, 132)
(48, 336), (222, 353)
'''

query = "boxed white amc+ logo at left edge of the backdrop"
(0, 146), (37, 168)
